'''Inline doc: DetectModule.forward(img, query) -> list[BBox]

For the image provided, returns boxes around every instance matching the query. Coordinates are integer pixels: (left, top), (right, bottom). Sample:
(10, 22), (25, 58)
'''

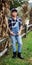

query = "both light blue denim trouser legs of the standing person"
(11, 35), (22, 52)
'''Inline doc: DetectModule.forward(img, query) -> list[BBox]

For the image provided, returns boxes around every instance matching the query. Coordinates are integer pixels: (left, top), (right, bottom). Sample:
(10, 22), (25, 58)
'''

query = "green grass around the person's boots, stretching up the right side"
(0, 32), (32, 65)
